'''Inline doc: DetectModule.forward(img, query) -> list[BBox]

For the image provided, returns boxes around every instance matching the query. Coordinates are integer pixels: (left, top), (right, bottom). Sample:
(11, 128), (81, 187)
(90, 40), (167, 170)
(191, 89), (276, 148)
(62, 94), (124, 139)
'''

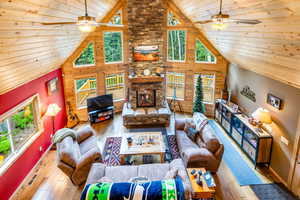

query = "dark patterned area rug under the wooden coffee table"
(103, 128), (180, 166)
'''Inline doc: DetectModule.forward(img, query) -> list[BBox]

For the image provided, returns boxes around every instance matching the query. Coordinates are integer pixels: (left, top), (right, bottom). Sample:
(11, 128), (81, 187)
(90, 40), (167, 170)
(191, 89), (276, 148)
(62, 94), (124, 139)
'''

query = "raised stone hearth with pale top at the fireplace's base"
(122, 102), (171, 127)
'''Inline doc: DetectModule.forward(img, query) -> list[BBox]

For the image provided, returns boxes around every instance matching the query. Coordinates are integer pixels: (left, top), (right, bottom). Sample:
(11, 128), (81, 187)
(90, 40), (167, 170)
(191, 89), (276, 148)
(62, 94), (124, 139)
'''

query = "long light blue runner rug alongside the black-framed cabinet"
(209, 120), (265, 186)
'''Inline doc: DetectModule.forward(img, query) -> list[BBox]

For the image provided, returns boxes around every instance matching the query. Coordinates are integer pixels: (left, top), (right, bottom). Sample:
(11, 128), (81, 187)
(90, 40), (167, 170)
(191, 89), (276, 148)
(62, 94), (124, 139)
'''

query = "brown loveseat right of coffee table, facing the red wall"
(175, 113), (224, 173)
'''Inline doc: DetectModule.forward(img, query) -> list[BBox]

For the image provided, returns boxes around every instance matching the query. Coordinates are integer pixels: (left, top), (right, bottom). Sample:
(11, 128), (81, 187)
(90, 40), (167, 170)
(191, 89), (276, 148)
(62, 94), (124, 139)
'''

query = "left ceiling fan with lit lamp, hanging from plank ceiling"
(41, 0), (123, 32)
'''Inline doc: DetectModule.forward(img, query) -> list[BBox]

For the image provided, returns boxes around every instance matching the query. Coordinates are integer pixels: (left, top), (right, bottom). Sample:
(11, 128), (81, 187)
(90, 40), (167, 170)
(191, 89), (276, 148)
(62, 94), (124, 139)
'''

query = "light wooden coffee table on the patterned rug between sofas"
(120, 132), (165, 164)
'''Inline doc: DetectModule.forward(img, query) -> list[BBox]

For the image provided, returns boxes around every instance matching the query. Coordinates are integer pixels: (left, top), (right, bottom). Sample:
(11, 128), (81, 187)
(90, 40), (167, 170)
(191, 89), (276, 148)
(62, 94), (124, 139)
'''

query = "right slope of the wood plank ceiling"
(174, 0), (300, 88)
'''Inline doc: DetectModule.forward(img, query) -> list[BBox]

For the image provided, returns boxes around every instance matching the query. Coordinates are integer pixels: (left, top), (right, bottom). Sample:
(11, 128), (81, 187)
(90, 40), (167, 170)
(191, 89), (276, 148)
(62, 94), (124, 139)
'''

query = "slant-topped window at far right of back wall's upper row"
(195, 40), (216, 63)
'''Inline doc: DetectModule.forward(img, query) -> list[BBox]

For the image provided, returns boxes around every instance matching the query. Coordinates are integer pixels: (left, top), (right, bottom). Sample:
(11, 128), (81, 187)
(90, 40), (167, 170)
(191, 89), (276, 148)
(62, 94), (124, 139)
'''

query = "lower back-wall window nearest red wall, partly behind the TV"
(75, 78), (97, 108)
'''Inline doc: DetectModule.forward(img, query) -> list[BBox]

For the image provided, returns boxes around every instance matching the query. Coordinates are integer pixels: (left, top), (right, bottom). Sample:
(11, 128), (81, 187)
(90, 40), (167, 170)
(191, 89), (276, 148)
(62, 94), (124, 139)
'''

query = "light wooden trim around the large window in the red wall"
(0, 94), (44, 176)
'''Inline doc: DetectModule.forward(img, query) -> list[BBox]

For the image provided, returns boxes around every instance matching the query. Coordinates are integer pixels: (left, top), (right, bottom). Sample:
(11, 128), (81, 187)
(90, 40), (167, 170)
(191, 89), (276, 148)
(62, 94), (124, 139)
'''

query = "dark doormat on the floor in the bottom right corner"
(250, 183), (299, 200)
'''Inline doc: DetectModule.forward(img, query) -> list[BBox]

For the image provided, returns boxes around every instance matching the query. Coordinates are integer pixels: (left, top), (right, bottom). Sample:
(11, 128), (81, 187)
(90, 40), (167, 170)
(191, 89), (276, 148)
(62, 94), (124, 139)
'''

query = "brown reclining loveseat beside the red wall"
(56, 125), (102, 185)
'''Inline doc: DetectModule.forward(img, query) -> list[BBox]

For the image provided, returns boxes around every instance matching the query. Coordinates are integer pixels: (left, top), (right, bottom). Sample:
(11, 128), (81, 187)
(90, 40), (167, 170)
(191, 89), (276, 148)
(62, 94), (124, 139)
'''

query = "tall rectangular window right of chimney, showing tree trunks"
(168, 30), (186, 62)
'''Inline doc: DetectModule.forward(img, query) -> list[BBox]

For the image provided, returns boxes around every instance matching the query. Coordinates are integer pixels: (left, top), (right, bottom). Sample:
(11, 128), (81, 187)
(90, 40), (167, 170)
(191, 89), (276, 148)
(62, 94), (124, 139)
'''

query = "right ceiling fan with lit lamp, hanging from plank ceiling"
(195, 0), (261, 30)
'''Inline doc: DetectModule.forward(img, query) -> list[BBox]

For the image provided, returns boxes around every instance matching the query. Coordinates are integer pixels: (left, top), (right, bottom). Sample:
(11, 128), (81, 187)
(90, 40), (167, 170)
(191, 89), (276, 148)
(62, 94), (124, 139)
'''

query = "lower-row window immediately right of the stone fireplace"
(166, 72), (185, 100)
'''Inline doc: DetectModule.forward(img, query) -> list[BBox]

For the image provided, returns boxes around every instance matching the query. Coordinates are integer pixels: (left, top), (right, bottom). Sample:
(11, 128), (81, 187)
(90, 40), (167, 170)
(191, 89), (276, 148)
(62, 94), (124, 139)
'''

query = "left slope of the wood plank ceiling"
(0, 0), (117, 94)
